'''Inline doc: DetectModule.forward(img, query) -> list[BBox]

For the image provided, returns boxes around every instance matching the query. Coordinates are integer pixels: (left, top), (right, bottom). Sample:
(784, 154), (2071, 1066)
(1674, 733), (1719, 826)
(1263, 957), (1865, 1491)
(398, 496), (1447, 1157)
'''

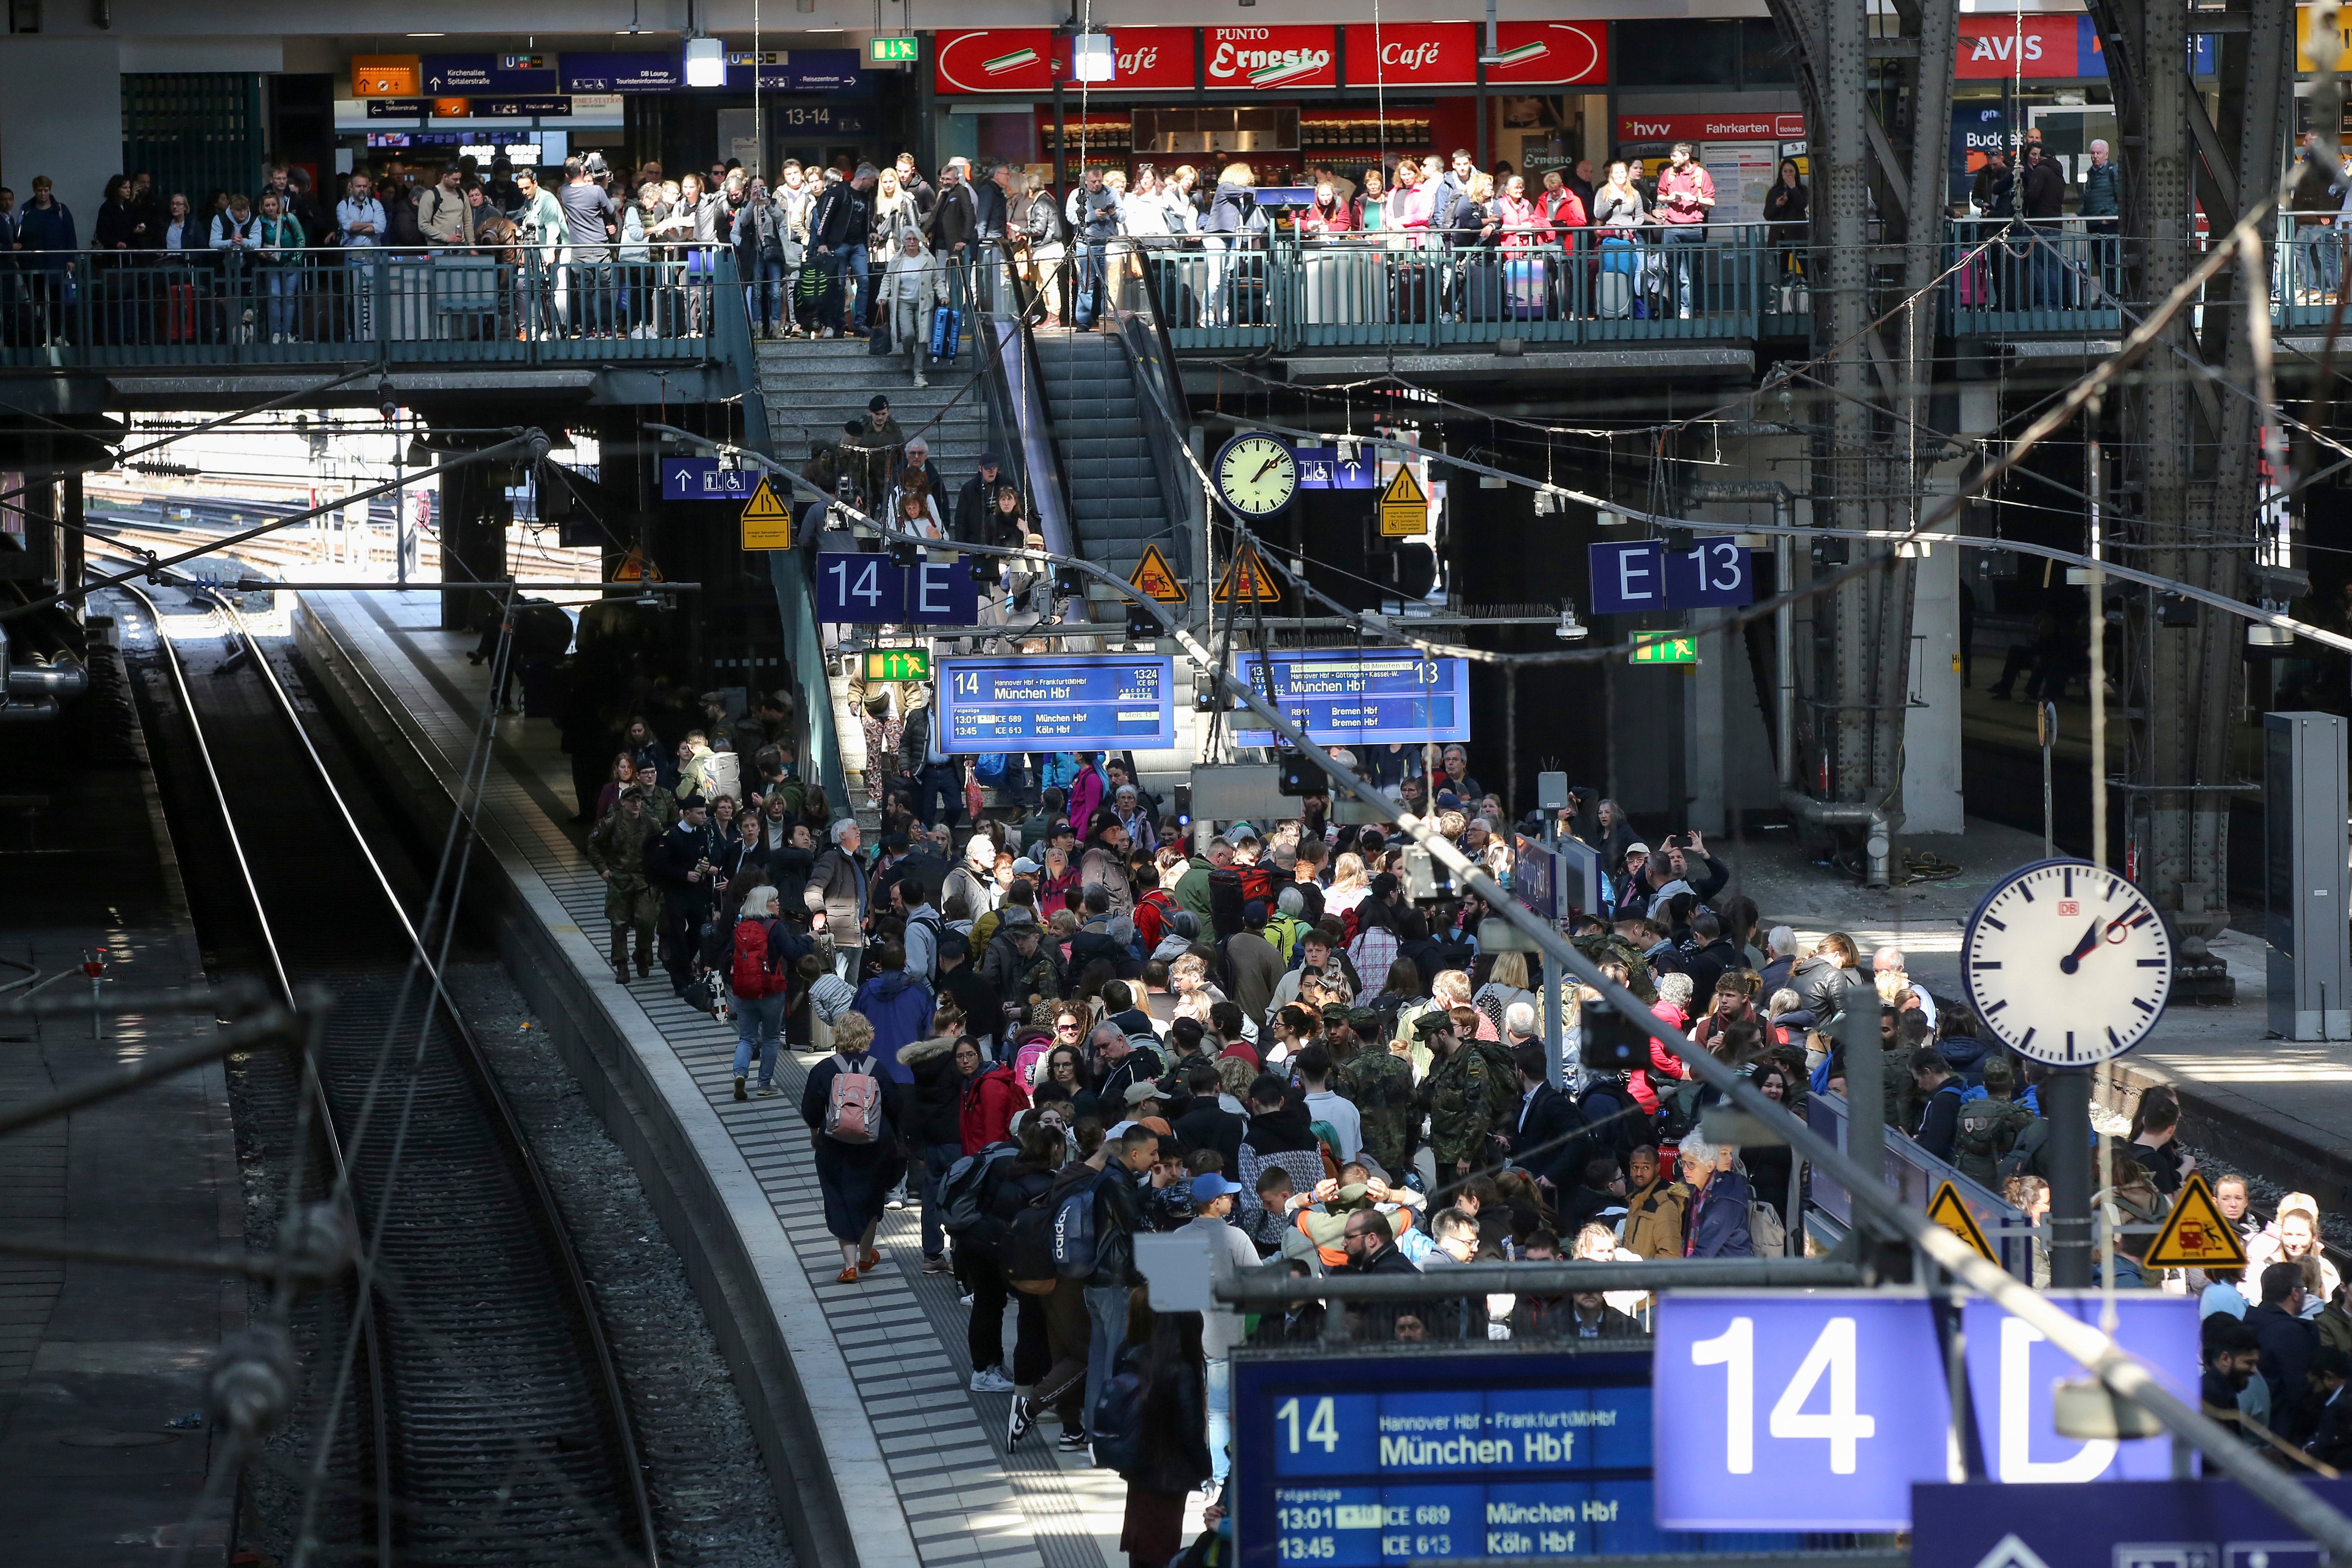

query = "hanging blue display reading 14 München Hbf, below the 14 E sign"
(938, 653), (1176, 752)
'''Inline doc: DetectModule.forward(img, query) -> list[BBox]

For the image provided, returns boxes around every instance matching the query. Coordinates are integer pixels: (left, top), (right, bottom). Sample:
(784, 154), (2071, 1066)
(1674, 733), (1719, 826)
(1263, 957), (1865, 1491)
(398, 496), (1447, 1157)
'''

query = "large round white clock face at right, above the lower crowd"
(1959, 860), (2173, 1067)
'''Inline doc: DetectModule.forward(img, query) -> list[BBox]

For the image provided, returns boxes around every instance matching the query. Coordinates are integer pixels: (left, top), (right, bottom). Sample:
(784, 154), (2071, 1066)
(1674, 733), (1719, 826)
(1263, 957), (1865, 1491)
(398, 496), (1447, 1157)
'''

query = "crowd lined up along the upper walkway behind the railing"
(0, 143), (1809, 350)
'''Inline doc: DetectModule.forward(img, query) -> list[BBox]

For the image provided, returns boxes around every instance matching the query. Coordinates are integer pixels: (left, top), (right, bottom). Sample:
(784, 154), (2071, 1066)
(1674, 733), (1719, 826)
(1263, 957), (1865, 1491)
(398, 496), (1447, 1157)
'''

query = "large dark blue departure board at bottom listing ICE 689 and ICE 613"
(1228, 1347), (1799, 1568)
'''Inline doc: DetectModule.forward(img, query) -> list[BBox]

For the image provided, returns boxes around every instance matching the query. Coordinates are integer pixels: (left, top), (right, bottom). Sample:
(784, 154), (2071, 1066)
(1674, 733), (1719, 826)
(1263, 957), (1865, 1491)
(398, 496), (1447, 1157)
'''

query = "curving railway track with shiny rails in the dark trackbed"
(125, 590), (659, 1568)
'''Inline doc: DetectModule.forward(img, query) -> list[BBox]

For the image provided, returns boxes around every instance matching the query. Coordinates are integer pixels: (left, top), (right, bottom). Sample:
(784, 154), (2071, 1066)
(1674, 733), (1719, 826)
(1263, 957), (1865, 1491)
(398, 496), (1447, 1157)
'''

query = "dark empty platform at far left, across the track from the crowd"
(0, 620), (247, 1568)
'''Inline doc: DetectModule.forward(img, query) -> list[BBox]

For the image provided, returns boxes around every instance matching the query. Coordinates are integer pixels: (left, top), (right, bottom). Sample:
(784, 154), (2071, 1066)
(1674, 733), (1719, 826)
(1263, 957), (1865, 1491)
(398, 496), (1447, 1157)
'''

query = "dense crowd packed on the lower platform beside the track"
(555, 710), (2352, 1563)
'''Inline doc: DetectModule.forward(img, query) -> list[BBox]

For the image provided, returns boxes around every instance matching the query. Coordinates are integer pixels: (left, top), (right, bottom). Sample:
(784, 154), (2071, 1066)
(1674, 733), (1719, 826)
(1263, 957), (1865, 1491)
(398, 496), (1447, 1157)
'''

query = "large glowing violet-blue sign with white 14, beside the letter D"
(1656, 1291), (1950, 1530)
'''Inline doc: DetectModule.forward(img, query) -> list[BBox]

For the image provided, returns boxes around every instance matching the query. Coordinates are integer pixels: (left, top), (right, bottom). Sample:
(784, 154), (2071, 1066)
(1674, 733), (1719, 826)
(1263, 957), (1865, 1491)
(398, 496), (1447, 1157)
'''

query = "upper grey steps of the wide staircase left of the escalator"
(757, 339), (988, 484)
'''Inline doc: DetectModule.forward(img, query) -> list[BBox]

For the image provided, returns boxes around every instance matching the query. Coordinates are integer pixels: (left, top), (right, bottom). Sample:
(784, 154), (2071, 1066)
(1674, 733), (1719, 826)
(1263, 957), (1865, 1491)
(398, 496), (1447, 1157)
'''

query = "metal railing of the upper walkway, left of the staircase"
(0, 247), (743, 369)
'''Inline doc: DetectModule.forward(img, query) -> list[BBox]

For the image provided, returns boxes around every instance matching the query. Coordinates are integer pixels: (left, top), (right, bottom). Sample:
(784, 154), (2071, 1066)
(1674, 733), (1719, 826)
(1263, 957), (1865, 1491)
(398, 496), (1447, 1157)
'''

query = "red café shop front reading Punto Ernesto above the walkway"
(931, 19), (1609, 186)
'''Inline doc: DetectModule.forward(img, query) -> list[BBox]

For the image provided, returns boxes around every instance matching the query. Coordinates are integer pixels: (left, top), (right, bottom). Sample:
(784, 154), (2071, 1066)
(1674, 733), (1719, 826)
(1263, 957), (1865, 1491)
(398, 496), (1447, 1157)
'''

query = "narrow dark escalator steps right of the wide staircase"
(1037, 332), (1169, 576)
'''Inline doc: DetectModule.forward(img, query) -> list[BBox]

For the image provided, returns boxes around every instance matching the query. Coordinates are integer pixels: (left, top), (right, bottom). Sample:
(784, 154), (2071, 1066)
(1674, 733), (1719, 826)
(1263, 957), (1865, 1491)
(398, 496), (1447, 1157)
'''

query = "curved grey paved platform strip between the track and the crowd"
(294, 592), (1200, 1568)
